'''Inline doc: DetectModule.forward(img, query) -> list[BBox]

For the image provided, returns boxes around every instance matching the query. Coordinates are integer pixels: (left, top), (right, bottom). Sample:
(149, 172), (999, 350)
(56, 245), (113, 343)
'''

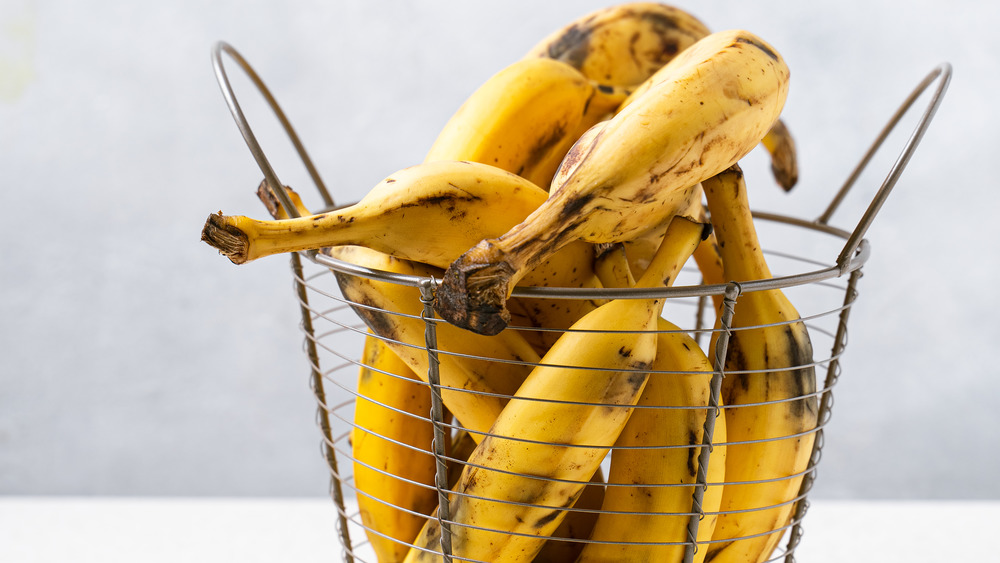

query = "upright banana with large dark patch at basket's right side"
(702, 165), (818, 563)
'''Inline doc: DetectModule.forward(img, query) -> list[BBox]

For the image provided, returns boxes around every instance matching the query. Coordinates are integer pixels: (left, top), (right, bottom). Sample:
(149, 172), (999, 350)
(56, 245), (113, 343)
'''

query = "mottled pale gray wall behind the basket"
(0, 0), (1000, 499)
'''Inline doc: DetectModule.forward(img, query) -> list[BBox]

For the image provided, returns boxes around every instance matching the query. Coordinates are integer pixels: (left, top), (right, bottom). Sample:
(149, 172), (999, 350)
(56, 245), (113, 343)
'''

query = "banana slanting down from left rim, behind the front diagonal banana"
(325, 246), (539, 442)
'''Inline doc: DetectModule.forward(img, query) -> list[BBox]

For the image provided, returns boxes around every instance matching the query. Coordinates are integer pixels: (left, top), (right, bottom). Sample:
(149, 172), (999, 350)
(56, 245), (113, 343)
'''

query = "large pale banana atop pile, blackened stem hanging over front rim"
(435, 30), (788, 334)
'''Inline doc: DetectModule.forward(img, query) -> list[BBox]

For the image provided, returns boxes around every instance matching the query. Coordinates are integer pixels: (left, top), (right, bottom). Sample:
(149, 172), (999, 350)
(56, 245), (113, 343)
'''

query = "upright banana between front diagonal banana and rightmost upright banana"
(576, 241), (726, 563)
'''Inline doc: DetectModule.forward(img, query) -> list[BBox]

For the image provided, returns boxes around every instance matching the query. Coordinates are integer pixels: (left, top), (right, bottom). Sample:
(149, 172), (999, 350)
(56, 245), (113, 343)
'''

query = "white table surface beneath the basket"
(0, 496), (1000, 563)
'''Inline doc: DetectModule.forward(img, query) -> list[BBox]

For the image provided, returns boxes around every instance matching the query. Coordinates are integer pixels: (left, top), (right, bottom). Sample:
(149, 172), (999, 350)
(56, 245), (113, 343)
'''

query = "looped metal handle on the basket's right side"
(816, 63), (951, 275)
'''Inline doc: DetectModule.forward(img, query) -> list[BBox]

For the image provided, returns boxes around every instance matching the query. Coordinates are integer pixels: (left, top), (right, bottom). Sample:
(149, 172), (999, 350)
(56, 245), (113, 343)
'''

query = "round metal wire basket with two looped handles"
(213, 42), (951, 562)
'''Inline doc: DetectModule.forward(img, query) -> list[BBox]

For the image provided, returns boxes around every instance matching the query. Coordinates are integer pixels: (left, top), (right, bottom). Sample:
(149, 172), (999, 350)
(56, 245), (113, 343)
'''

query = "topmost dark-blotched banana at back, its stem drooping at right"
(525, 2), (798, 191)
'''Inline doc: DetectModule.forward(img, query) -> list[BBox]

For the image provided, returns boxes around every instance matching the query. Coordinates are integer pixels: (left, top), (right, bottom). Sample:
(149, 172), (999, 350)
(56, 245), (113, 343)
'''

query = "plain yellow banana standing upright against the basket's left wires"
(351, 336), (438, 563)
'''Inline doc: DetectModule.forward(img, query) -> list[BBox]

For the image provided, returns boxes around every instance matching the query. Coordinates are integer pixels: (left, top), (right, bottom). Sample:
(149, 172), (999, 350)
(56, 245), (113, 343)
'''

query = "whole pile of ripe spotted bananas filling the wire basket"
(201, 2), (817, 563)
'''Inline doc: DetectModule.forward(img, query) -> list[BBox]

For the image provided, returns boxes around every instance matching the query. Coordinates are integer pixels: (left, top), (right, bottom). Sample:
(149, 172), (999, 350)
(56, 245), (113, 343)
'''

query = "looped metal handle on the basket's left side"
(212, 41), (333, 217)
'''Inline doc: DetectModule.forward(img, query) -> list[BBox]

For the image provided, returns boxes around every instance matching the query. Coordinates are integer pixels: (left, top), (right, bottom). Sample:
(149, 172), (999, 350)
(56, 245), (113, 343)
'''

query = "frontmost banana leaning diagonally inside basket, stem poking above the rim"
(406, 218), (706, 563)
